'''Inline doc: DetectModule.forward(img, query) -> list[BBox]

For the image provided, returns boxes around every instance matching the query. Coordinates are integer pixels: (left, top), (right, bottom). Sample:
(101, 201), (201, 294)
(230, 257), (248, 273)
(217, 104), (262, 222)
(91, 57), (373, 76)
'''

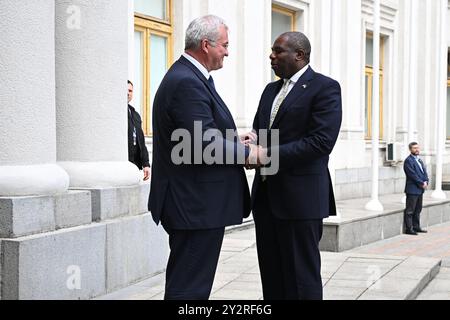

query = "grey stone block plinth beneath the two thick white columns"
(0, 184), (169, 300)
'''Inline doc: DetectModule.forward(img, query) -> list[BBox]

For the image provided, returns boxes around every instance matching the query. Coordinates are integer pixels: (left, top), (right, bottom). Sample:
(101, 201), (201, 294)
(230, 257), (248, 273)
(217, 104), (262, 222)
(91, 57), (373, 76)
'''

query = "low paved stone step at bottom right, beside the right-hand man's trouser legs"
(323, 254), (440, 300)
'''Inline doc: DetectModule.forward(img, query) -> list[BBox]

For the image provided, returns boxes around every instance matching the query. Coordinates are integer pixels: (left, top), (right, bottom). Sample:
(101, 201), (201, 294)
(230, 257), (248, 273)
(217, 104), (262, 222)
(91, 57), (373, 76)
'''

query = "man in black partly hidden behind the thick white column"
(128, 80), (150, 181)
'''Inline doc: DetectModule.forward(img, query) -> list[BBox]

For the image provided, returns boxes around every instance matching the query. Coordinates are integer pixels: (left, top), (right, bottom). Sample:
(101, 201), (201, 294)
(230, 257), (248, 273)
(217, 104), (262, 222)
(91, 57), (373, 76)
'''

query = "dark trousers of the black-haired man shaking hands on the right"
(253, 183), (323, 300)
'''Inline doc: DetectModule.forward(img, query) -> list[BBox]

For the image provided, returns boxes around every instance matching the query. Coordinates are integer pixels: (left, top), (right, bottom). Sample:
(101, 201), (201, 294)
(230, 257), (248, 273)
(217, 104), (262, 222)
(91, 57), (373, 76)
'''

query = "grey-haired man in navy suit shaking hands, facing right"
(149, 16), (256, 300)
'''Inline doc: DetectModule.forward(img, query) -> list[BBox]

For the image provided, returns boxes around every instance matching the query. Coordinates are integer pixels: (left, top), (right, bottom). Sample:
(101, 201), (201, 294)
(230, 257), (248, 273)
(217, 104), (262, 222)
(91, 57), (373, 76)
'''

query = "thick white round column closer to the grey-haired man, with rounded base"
(56, 0), (139, 188)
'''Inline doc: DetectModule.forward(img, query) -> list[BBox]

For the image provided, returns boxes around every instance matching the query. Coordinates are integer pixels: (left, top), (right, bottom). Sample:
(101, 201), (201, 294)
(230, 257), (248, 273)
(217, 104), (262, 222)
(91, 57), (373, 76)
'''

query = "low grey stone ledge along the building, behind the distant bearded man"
(320, 192), (450, 252)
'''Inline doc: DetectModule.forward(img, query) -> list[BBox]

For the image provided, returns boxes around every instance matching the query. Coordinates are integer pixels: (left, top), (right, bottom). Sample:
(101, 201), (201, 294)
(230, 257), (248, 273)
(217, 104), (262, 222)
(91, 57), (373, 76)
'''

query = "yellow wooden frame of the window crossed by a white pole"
(364, 31), (386, 141)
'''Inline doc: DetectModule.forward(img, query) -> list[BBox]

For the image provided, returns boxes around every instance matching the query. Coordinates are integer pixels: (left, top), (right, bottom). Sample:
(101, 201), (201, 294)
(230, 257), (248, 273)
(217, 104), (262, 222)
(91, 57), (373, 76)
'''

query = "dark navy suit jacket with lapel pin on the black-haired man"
(252, 67), (342, 220)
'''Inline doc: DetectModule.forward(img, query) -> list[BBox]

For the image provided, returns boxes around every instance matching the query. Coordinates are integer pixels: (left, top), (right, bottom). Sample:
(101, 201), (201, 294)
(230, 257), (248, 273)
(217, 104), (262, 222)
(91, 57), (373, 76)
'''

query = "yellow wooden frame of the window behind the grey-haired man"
(134, 0), (174, 137)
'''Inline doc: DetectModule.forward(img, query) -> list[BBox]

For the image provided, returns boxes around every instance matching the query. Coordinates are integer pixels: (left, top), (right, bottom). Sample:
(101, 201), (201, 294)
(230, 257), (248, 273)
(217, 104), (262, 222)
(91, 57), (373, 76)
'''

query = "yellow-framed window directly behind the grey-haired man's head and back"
(133, 0), (173, 136)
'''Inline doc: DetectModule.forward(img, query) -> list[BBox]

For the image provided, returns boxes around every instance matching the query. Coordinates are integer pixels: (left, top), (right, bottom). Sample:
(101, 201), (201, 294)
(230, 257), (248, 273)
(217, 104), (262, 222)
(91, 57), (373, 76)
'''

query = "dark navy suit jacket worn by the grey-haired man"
(149, 57), (250, 230)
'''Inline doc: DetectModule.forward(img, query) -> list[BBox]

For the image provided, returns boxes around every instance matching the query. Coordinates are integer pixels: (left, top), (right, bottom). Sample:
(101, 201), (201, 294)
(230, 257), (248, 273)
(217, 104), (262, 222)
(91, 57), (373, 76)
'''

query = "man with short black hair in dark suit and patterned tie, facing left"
(252, 32), (342, 300)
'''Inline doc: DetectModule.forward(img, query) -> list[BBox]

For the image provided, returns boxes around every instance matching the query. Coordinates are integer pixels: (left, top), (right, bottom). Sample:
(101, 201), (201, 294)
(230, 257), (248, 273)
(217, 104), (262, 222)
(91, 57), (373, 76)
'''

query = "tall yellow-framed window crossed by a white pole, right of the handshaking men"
(364, 33), (385, 139)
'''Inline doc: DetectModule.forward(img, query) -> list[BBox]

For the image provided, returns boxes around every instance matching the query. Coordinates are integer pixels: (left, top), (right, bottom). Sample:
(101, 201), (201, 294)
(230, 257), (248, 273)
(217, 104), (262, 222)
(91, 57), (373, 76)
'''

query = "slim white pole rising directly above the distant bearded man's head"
(408, 0), (419, 144)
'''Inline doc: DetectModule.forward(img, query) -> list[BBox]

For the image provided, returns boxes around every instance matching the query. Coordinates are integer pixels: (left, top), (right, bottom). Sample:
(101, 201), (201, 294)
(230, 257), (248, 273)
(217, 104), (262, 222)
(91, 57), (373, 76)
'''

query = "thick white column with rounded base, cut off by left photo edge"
(0, 0), (69, 197)
